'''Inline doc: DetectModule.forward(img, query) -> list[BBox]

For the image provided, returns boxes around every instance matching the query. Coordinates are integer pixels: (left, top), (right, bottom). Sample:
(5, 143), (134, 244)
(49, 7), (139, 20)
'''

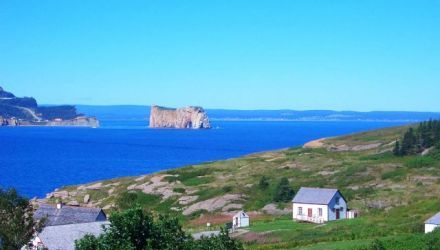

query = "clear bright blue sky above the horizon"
(0, 0), (440, 111)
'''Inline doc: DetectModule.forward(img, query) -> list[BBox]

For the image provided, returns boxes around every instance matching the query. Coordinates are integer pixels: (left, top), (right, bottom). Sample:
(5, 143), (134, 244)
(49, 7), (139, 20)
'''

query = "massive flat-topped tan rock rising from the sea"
(150, 106), (211, 129)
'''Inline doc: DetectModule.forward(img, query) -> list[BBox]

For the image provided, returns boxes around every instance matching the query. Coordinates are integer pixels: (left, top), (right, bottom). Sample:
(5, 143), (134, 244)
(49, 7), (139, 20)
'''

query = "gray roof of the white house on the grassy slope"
(292, 187), (339, 205)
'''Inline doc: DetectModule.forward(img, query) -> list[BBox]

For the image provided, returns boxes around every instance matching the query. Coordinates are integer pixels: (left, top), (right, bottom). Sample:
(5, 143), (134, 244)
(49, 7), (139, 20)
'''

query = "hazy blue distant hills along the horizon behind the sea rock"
(77, 105), (440, 122)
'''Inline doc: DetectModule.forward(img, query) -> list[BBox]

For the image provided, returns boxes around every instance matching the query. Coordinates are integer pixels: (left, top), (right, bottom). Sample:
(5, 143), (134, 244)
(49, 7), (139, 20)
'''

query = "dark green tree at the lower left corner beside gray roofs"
(0, 188), (41, 250)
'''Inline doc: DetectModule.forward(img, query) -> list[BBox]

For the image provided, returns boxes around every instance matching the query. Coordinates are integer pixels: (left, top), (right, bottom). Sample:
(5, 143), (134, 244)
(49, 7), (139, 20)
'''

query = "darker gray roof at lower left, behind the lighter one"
(34, 204), (107, 226)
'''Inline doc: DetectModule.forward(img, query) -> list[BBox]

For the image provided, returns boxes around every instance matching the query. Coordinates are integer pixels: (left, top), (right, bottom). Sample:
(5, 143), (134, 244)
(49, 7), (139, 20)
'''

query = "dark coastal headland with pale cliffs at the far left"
(0, 87), (99, 127)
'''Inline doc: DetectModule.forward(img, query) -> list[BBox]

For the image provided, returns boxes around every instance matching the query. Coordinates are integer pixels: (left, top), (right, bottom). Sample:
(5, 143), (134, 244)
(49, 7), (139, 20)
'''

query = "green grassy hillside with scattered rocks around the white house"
(43, 124), (440, 249)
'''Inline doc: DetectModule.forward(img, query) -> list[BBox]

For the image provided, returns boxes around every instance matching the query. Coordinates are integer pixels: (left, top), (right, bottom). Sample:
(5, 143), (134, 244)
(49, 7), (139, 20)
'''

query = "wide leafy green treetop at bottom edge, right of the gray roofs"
(75, 207), (242, 250)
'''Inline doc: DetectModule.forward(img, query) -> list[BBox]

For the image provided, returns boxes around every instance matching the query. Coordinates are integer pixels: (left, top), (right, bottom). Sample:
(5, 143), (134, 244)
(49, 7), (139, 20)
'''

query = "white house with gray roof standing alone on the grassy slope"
(292, 187), (348, 223)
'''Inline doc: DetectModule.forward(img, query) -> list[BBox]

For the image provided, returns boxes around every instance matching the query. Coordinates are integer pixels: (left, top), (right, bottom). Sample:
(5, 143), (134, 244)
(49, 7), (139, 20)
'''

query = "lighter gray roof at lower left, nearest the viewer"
(38, 221), (110, 250)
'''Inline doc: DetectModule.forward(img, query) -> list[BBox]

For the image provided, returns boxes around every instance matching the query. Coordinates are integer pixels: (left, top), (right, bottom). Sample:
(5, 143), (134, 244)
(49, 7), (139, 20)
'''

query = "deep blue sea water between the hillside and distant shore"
(0, 121), (401, 198)
